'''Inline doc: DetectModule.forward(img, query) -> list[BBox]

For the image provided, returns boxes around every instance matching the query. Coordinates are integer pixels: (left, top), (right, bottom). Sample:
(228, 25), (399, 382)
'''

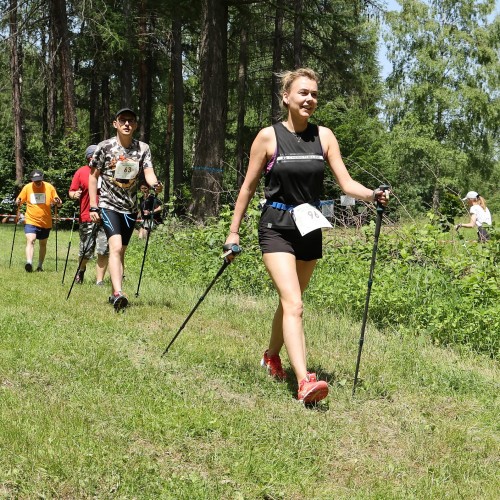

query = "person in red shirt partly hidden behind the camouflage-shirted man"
(69, 144), (108, 286)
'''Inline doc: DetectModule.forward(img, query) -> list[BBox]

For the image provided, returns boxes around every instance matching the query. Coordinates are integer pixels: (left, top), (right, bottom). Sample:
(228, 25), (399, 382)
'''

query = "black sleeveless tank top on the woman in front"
(260, 123), (325, 229)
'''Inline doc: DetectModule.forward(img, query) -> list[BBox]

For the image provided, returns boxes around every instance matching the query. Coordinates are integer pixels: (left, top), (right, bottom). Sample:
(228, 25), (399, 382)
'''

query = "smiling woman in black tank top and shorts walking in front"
(226, 68), (388, 403)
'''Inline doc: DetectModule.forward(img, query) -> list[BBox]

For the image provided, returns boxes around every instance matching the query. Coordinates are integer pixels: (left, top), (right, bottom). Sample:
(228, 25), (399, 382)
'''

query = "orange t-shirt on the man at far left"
(18, 182), (59, 229)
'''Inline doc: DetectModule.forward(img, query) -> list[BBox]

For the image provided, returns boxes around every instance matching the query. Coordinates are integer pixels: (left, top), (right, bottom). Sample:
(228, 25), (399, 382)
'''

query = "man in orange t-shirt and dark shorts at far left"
(16, 170), (62, 273)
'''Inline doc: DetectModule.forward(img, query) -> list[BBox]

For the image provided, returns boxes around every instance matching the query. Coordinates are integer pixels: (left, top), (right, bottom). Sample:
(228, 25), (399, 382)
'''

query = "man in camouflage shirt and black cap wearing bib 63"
(89, 108), (162, 311)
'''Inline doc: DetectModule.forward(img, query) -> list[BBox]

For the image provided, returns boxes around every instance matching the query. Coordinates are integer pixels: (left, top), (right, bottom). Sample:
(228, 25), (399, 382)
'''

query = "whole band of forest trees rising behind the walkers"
(0, 0), (500, 224)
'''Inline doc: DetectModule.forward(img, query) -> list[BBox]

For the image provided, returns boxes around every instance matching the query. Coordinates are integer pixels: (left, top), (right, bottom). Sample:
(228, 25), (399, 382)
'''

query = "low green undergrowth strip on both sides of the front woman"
(133, 217), (500, 357)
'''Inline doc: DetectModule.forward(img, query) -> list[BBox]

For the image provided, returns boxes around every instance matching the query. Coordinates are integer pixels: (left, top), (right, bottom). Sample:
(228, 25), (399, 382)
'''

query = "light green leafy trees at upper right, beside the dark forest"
(384, 0), (500, 212)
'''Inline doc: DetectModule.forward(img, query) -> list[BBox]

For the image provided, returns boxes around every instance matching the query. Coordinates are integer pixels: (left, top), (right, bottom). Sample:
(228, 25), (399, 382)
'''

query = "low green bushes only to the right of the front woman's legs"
(316, 224), (500, 357)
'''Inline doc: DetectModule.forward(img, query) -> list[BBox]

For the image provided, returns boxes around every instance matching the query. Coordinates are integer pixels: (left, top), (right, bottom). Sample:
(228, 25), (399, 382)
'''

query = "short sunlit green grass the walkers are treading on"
(0, 227), (500, 499)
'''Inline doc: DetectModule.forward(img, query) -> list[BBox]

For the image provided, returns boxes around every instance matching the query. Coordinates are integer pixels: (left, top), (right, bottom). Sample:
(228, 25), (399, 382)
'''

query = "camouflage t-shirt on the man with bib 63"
(89, 137), (153, 213)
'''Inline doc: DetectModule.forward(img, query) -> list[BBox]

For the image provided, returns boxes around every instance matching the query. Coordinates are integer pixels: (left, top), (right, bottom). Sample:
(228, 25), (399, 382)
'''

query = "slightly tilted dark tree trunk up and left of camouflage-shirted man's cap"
(50, 0), (77, 134)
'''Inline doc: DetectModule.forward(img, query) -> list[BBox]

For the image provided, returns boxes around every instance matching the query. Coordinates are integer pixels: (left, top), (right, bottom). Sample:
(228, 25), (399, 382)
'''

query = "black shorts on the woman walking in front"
(259, 227), (323, 260)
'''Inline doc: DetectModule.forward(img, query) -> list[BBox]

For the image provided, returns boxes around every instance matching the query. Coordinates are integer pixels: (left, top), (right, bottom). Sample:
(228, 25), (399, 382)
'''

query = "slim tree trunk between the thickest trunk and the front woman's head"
(236, 19), (248, 188)
